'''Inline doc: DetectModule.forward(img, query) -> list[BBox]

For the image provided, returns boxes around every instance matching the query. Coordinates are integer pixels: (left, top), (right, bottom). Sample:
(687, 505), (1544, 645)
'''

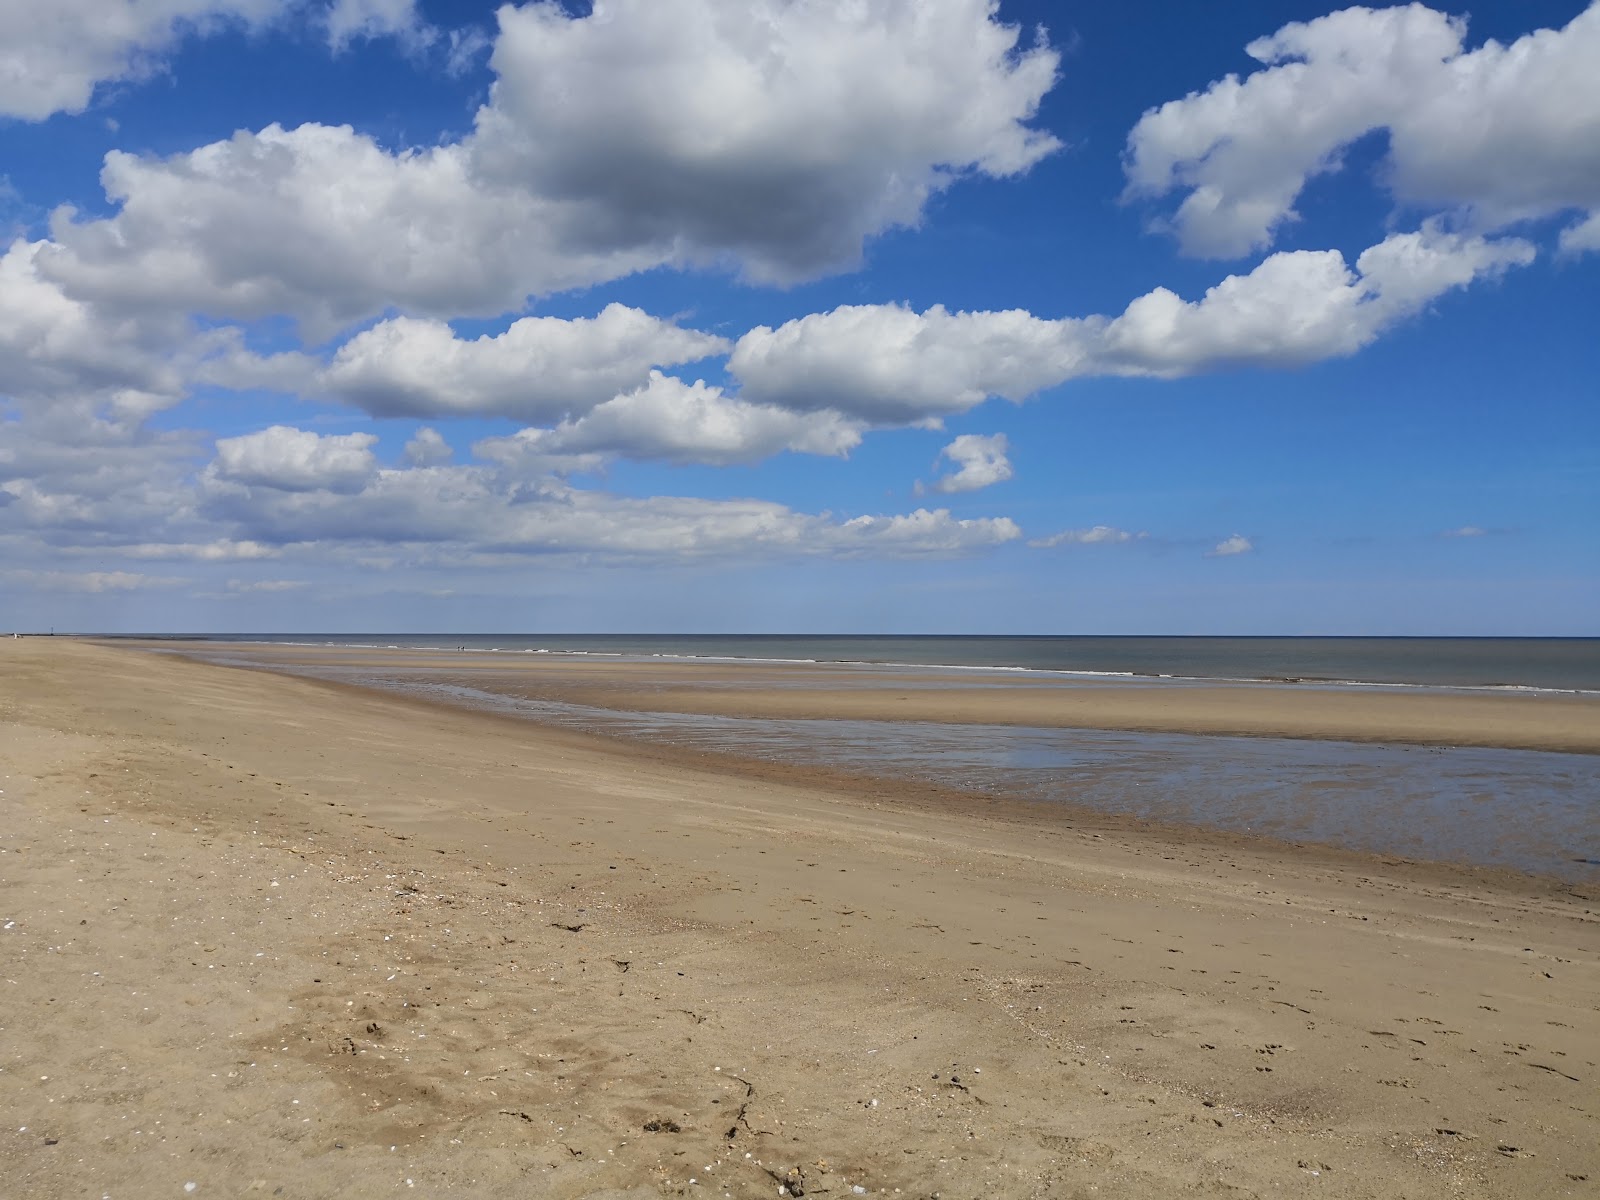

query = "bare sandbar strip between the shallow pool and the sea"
(150, 643), (1600, 754)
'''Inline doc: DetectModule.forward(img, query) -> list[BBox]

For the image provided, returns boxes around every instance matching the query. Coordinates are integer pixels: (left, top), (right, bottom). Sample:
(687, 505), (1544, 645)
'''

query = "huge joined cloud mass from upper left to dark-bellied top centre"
(34, 0), (1056, 338)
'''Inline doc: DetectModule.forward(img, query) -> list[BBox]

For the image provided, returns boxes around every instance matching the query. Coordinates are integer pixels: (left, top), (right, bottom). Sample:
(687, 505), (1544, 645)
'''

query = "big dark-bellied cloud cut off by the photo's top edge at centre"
(478, 0), (1058, 280)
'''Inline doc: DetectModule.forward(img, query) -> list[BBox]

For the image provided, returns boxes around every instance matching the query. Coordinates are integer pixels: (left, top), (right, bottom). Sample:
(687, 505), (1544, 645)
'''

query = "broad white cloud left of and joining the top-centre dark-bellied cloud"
(42, 125), (636, 339)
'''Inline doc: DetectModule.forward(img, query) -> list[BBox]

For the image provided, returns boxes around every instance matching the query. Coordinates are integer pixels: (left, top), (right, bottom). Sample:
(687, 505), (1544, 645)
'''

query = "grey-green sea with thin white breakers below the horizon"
(137, 634), (1600, 693)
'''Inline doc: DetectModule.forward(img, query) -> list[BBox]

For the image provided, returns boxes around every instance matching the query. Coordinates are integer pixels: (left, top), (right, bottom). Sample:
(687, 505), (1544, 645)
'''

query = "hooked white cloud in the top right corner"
(1126, 3), (1600, 258)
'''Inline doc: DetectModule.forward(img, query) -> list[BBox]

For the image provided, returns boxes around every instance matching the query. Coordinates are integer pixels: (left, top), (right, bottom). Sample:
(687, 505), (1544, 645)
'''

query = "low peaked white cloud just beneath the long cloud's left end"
(478, 371), (861, 466)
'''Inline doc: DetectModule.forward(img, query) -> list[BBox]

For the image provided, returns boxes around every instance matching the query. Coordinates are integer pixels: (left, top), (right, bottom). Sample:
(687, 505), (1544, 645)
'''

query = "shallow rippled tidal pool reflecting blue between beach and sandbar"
(228, 659), (1600, 882)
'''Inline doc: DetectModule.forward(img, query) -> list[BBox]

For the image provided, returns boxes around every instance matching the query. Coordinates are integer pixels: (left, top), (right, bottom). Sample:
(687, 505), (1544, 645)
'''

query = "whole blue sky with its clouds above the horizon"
(0, 0), (1600, 635)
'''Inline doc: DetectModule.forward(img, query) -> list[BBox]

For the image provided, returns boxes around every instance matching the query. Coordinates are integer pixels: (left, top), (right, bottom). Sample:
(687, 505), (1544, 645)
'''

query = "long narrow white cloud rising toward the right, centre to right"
(728, 222), (1534, 424)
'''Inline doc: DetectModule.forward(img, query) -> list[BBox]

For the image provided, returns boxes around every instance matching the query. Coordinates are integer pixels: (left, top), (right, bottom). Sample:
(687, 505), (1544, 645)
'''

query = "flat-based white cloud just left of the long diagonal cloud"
(320, 304), (728, 422)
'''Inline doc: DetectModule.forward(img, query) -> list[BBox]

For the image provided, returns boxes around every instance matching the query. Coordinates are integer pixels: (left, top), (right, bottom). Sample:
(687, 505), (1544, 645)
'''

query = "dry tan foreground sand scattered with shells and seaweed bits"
(0, 640), (1600, 1200)
